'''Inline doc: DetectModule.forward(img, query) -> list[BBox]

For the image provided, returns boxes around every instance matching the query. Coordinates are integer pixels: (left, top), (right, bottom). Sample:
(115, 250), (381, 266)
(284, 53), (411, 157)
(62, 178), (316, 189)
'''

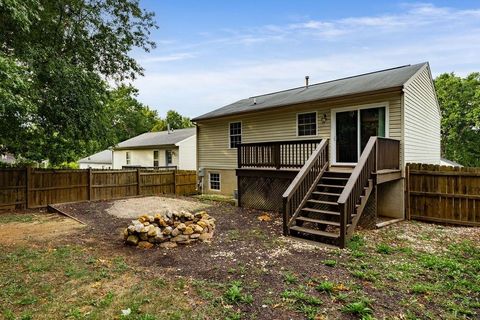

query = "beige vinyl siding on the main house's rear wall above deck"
(197, 92), (402, 169)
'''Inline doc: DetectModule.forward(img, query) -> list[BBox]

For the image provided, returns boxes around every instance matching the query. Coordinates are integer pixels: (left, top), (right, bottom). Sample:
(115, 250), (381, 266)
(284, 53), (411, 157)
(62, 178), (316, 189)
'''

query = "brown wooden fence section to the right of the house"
(406, 163), (480, 226)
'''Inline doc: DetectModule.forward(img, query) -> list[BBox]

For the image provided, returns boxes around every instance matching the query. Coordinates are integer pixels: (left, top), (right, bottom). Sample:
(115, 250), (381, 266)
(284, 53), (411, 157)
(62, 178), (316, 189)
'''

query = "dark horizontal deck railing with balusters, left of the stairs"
(237, 140), (321, 169)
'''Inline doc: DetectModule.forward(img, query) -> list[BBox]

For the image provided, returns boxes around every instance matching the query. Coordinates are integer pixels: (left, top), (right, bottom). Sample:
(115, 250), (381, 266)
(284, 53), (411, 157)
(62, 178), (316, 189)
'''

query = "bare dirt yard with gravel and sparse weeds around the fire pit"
(0, 197), (480, 319)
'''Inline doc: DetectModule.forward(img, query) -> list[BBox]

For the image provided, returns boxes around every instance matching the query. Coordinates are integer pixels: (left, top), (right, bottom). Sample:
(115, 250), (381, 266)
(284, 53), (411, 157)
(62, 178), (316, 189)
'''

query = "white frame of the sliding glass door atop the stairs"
(330, 101), (390, 166)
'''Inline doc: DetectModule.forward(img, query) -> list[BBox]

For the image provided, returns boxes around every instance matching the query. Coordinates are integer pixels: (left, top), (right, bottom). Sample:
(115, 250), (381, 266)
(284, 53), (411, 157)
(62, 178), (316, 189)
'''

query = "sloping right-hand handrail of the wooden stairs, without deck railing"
(337, 136), (378, 248)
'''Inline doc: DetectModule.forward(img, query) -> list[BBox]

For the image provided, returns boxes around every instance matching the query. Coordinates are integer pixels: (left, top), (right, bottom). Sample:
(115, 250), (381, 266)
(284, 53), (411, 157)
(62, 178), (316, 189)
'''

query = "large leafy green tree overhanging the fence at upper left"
(0, 0), (156, 164)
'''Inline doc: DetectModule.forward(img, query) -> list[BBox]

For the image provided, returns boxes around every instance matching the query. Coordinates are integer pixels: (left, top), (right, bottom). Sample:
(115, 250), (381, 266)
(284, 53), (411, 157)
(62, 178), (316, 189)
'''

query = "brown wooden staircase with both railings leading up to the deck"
(283, 137), (399, 248)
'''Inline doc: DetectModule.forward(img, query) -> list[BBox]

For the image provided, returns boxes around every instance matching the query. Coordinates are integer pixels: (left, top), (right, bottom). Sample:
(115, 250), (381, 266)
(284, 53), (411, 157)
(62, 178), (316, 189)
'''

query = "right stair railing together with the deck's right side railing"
(337, 137), (400, 248)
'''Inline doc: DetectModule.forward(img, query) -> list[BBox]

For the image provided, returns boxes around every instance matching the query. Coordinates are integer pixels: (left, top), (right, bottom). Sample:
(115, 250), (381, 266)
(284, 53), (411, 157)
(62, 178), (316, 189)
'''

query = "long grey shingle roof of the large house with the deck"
(192, 62), (428, 121)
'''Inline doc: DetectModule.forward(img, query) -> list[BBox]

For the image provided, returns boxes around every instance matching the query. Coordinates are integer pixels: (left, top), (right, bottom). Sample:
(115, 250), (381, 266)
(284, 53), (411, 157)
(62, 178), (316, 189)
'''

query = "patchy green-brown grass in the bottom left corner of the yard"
(0, 246), (204, 319)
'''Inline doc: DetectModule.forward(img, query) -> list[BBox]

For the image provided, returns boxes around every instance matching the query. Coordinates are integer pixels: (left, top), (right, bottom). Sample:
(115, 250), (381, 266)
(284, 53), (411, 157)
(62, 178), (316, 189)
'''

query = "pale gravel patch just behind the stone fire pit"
(106, 197), (209, 219)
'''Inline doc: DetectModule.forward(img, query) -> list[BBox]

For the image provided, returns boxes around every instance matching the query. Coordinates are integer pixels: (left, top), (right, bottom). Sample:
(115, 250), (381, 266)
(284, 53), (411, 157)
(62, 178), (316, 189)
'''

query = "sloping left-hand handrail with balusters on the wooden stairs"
(283, 139), (328, 235)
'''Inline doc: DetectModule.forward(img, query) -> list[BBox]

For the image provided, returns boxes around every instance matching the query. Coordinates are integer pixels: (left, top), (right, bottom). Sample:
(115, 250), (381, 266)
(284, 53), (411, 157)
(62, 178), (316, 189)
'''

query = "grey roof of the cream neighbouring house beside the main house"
(115, 128), (196, 149)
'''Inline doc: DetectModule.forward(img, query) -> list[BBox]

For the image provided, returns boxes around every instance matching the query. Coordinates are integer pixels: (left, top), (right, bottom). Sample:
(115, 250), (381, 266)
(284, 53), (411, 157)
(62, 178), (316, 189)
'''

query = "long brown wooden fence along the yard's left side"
(0, 168), (197, 209)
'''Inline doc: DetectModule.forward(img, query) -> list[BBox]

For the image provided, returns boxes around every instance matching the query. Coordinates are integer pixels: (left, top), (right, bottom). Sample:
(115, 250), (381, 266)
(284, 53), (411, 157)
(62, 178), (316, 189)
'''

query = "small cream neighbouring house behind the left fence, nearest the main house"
(113, 128), (197, 170)
